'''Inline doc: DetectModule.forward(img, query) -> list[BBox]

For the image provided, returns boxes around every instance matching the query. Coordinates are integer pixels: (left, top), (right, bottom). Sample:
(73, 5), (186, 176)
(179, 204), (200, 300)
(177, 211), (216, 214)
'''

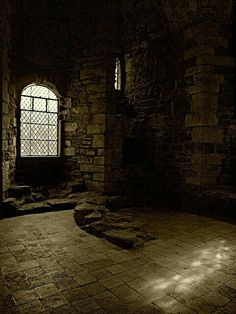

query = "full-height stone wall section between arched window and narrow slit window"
(65, 1), (119, 190)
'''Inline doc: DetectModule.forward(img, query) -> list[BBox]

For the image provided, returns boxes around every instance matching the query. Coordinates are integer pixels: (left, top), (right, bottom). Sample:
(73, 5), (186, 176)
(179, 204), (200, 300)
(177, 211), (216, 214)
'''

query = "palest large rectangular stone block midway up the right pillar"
(192, 127), (222, 144)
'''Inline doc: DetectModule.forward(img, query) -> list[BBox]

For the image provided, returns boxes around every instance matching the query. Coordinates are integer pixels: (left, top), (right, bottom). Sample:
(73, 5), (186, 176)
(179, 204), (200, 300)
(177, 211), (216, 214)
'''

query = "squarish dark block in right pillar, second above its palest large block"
(191, 93), (218, 113)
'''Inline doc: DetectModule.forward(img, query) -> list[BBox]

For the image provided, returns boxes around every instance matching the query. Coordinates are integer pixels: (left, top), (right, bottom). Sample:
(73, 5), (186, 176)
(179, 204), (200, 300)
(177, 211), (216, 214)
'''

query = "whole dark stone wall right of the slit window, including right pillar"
(107, 0), (235, 202)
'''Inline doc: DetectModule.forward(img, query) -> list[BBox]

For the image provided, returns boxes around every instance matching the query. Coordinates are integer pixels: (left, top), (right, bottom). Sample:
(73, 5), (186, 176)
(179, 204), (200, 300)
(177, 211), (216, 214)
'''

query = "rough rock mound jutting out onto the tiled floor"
(72, 192), (155, 248)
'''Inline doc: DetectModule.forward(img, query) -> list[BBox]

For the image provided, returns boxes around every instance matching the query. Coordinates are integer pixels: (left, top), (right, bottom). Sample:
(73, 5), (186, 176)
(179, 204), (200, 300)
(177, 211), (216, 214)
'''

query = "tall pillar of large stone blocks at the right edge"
(184, 3), (235, 187)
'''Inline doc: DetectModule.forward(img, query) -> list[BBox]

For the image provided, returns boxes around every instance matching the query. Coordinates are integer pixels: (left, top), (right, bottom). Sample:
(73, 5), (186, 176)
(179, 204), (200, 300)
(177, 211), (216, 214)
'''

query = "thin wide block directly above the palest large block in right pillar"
(185, 112), (218, 127)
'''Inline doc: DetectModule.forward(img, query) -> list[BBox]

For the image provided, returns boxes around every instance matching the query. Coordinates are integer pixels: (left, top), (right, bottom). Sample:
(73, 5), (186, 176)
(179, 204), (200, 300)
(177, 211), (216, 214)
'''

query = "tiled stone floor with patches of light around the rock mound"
(0, 210), (236, 314)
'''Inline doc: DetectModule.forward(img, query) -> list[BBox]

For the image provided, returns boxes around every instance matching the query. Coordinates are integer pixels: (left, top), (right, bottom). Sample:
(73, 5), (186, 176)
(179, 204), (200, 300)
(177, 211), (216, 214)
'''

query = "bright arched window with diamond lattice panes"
(20, 84), (59, 157)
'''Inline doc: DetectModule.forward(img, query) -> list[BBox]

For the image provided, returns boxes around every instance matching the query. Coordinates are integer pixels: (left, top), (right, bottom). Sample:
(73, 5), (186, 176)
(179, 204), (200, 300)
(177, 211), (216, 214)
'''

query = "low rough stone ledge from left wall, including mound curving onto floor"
(0, 185), (154, 248)
